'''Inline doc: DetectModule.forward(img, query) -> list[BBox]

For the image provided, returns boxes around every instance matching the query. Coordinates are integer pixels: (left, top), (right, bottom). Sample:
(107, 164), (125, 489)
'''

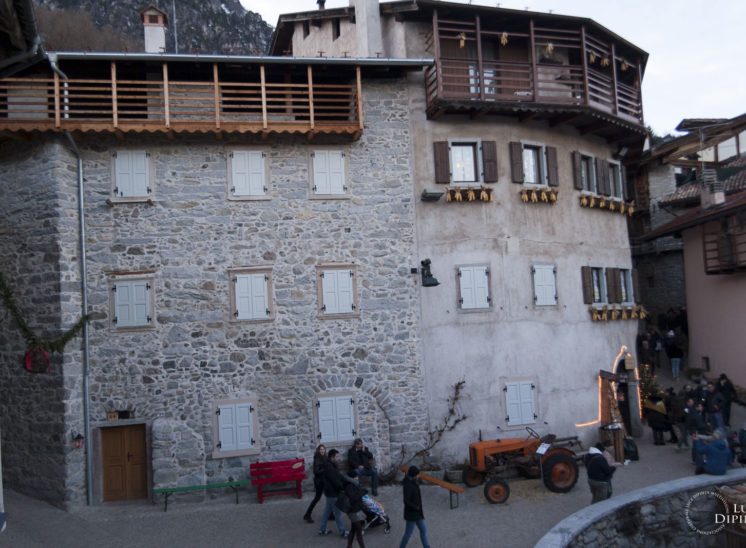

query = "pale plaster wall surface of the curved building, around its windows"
(410, 75), (637, 462)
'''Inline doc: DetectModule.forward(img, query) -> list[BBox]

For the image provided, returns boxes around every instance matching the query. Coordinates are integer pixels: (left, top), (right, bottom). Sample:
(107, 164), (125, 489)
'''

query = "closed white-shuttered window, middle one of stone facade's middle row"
(228, 267), (274, 321)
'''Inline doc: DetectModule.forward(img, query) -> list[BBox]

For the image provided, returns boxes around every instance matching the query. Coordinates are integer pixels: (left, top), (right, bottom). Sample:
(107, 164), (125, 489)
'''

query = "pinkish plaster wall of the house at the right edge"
(682, 227), (746, 386)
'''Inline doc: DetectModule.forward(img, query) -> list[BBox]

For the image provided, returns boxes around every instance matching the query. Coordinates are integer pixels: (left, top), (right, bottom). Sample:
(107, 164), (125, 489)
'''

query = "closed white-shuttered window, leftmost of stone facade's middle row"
(109, 274), (154, 329)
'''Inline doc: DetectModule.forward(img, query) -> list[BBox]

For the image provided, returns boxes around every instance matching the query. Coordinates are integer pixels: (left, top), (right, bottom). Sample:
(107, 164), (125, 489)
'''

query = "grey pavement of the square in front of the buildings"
(0, 368), (746, 548)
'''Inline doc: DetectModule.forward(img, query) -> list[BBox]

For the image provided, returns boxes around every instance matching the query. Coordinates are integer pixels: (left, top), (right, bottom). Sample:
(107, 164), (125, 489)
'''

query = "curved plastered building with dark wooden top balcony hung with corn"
(271, 0), (647, 462)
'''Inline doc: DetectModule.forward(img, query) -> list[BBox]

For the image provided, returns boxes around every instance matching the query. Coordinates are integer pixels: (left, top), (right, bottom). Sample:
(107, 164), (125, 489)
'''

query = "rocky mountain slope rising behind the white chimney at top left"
(34, 0), (273, 55)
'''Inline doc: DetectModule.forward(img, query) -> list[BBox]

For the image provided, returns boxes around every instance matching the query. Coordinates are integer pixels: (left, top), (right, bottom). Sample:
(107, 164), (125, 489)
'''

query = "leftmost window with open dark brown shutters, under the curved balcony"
(433, 139), (497, 186)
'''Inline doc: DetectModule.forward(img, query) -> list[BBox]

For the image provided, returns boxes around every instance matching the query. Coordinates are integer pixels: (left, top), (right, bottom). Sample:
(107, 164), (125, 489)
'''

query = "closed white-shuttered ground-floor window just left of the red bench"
(212, 398), (259, 458)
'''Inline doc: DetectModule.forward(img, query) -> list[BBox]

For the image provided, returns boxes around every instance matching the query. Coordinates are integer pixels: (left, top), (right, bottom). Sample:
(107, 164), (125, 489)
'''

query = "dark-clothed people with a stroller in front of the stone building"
(303, 438), (430, 548)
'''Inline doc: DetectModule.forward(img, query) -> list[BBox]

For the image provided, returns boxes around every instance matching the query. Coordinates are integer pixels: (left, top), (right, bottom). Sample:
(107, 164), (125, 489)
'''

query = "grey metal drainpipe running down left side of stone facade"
(49, 55), (93, 506)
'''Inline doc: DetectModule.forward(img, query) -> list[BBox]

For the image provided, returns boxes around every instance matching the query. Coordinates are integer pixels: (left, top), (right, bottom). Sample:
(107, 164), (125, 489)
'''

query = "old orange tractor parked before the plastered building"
(463, 426), (582, 504)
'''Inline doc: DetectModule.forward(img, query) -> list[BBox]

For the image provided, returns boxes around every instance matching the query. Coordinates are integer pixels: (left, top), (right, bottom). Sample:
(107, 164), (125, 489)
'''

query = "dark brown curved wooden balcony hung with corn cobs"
(426, 10), (644, 140)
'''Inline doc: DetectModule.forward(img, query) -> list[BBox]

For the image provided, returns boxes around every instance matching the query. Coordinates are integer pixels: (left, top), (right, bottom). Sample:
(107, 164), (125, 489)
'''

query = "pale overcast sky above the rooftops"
(241, 0), (746, 135)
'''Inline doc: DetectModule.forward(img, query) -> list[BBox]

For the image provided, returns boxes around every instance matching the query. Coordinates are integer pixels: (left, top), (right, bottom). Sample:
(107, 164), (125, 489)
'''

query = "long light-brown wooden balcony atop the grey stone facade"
(0, 61), (363, 139)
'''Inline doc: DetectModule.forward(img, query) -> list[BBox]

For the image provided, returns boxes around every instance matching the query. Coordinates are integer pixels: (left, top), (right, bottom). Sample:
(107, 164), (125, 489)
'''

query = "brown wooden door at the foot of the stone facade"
(101, 424), (148, 501)
